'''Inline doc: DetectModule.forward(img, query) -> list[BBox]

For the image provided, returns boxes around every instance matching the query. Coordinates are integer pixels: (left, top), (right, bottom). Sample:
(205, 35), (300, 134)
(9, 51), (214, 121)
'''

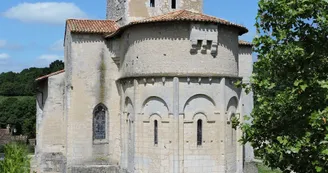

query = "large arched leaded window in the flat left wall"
(93, 104), (107, 140)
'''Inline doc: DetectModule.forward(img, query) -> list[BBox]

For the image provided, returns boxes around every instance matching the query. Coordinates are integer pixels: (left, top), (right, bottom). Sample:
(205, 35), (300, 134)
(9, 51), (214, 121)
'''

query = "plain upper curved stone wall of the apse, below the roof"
(120, 23), (238, 77)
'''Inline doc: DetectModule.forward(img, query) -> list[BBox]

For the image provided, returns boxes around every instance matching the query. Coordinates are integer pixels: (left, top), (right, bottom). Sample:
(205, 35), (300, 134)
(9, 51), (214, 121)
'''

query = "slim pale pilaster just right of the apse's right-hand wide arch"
(218, 78), (227, 173)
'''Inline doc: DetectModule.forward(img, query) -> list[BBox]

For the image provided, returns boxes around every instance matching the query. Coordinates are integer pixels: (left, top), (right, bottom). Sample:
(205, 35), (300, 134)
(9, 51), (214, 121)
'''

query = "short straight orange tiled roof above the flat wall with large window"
(66, 19), (119, 34)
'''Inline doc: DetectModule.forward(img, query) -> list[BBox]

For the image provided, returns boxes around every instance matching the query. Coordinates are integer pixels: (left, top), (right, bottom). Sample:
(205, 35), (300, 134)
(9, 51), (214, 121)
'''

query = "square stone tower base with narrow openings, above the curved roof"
(107, 0), (203, 25)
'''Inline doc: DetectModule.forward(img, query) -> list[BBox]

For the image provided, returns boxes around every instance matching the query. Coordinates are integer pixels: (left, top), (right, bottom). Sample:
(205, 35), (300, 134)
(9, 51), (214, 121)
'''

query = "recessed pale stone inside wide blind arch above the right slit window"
(183, 94), (215, 121)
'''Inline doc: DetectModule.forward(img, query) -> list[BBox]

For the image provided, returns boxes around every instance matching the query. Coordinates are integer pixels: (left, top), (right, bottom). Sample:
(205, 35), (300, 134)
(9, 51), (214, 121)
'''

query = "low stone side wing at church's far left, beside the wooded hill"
(35, 73), (66, 172)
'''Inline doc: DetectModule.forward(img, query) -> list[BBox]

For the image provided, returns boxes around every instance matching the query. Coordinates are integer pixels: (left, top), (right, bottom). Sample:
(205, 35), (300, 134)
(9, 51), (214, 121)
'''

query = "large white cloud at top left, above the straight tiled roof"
(3, 2), (87, 24)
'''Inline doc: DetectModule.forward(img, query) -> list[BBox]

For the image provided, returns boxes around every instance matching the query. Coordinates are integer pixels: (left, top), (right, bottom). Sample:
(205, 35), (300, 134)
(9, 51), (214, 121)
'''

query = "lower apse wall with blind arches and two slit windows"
(121, 77), (242, 173)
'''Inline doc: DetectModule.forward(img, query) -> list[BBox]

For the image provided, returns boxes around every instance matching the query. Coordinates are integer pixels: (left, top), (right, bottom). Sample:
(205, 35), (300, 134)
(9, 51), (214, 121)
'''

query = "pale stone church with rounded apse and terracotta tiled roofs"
(33, 0), (253, 173)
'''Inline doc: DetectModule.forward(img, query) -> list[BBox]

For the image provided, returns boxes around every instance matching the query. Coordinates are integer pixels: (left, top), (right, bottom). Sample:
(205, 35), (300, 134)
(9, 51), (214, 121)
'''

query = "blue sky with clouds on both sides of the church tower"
(0, 0), (257, 73)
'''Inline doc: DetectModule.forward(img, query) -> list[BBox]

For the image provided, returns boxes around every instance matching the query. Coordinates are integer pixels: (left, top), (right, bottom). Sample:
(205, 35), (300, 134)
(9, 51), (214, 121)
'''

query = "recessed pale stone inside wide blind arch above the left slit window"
(142, 96), (169, 118)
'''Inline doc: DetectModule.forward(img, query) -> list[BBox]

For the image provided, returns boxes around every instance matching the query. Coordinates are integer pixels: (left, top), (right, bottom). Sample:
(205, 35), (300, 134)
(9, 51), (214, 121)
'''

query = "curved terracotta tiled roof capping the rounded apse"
(107, 10), (248, 37)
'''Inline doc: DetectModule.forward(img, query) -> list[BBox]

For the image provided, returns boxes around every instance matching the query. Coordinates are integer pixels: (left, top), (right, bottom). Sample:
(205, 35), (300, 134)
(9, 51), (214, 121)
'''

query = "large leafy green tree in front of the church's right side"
(242, 0), (328, 173)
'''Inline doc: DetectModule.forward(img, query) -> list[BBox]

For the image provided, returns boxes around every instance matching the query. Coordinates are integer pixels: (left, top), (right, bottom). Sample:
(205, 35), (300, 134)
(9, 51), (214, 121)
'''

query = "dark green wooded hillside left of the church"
(0, 60), (64, 138)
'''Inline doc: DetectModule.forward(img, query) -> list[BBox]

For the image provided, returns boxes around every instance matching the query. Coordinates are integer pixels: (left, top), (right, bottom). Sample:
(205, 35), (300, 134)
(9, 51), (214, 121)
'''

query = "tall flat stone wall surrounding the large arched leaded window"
(66, 34), (120, 168)
